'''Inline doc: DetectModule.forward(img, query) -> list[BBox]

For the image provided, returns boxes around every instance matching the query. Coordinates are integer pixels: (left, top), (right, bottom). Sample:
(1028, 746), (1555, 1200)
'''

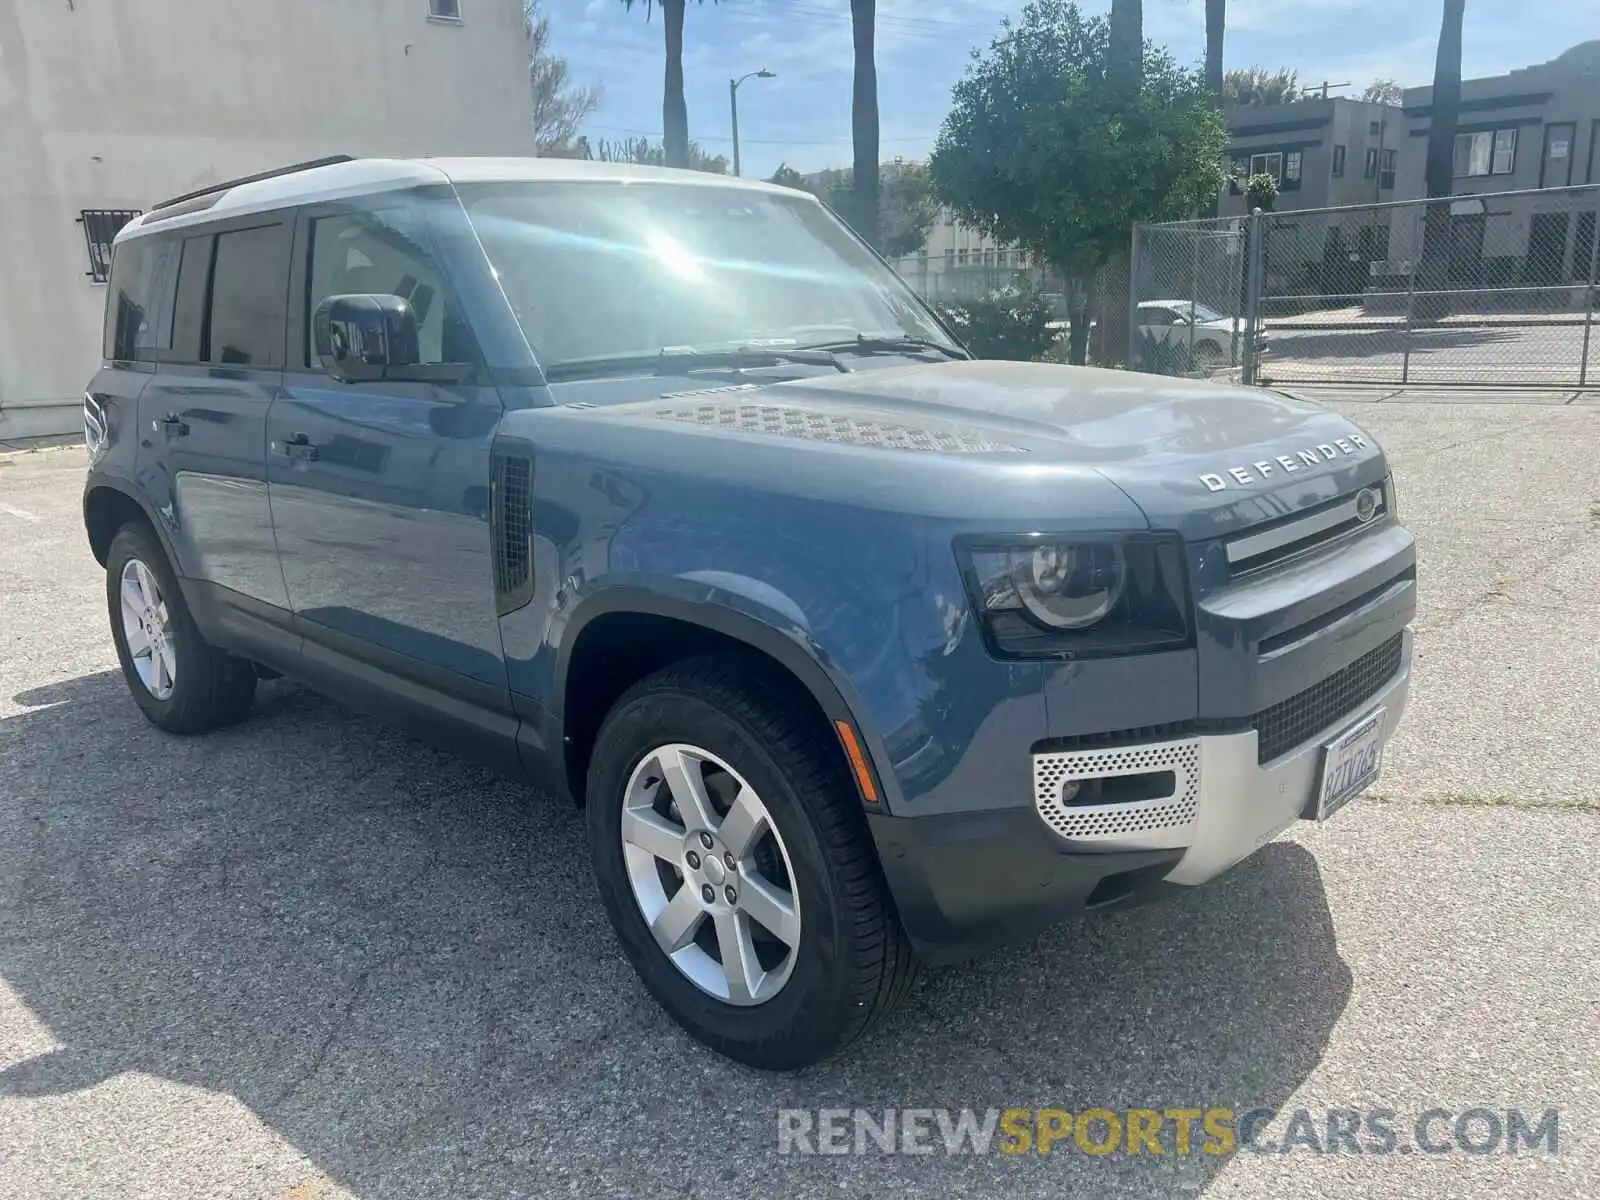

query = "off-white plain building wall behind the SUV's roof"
(0, 0), (534, 440)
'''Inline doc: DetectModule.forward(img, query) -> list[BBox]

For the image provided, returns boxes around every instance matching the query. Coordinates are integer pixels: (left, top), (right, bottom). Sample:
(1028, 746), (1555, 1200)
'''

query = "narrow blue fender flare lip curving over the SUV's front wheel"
(552, 576), (899, 813)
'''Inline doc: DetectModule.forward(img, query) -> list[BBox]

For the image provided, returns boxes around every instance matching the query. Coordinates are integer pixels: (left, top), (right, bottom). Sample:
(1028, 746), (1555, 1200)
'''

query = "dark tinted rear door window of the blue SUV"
(205, 226), (290, 368)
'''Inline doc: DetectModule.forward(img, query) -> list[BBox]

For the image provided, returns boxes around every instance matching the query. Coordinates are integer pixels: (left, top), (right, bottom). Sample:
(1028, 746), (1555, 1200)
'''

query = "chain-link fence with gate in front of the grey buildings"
(1128, 186), (1600, 387)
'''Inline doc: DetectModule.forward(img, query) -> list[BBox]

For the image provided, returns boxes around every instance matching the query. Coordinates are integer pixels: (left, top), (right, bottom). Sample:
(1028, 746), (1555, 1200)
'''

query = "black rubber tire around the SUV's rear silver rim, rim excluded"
(106, 522), (256, 733)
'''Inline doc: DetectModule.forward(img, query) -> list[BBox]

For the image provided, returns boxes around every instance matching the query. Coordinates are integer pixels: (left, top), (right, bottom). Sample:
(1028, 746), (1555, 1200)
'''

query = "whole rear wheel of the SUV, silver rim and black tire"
(106, 522), (256, 733)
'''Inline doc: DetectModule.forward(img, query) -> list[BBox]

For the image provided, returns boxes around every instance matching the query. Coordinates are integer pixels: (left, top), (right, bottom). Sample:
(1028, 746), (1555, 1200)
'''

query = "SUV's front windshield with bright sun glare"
(461, 181), (952, 370)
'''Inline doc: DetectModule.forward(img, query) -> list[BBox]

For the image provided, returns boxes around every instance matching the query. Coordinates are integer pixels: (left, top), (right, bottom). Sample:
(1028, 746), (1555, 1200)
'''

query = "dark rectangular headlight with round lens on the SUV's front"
(960, 534), (1189, 658)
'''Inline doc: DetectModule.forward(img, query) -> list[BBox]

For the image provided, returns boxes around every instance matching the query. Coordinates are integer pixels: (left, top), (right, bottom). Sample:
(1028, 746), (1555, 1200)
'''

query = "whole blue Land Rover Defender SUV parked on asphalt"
(83, 158), (1416, 1069)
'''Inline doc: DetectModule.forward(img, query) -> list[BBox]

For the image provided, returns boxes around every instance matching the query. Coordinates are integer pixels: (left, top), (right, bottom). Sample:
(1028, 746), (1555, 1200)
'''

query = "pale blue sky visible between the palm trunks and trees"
(544, 0), (1600, 176)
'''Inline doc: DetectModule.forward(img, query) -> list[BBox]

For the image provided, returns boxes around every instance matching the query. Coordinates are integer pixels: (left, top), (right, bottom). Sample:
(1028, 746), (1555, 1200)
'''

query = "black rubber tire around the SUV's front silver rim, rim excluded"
(587, 656), (917, 1070)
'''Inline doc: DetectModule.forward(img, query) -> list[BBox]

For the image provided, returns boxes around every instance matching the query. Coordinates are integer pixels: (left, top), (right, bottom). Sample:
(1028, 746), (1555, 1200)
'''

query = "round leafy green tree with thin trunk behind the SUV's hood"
(931, 0), (1227, 363)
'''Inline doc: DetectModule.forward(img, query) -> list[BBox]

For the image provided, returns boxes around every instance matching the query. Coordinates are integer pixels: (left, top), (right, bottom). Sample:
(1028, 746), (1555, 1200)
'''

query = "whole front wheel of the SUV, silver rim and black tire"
(587, 659), (915, 1070)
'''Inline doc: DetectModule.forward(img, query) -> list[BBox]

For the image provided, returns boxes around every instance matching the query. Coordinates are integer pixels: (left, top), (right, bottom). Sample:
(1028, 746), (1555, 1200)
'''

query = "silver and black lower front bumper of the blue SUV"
(870, 626), (1413, 962)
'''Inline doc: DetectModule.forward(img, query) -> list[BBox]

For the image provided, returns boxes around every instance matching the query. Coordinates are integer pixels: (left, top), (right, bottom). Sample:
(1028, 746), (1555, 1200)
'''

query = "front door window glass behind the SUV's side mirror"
(306, 208), (464, 366)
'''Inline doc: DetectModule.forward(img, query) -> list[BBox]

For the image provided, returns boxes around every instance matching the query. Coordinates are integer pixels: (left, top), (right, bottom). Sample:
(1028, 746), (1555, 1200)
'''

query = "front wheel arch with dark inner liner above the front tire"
(554, 587), (893, 808)
